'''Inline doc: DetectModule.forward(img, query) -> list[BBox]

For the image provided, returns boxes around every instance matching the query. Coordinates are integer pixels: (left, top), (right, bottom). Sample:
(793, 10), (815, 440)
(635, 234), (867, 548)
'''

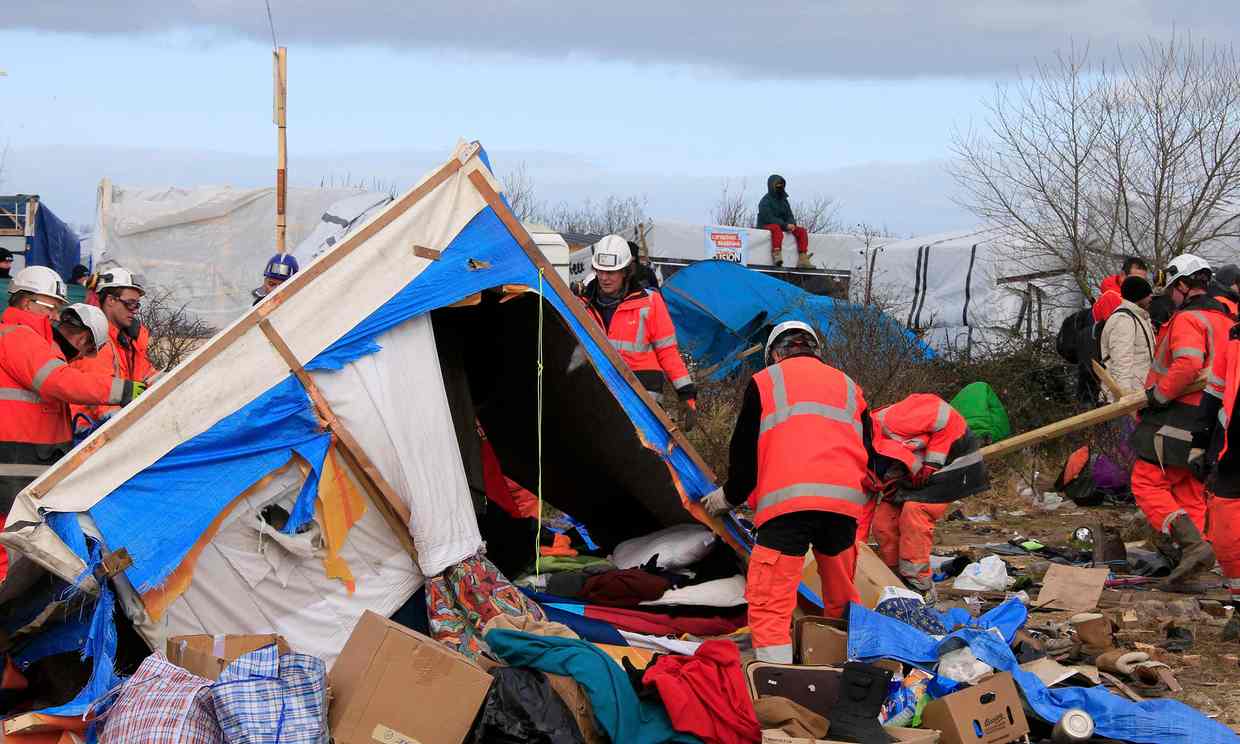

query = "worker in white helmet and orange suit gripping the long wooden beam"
(1130, 254), (1233, 591)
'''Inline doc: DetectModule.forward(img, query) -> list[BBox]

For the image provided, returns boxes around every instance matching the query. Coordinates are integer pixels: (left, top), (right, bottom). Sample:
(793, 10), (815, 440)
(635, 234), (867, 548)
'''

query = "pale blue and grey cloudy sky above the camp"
(0, 0), (1240, 233)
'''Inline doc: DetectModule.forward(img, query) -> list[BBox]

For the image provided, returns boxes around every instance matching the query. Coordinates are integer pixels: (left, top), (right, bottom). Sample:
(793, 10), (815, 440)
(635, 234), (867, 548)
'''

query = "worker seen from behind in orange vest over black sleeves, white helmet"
(703, 321), (872, 662)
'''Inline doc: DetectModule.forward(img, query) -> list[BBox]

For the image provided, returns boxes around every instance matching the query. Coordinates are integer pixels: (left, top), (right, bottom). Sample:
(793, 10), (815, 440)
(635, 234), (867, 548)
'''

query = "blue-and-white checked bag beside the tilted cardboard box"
(211, 645), (329, 744)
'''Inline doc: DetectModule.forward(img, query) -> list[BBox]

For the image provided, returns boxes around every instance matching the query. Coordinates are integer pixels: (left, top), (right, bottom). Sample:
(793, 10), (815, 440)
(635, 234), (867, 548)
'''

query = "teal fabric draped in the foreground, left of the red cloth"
(485, 630), (701, 744)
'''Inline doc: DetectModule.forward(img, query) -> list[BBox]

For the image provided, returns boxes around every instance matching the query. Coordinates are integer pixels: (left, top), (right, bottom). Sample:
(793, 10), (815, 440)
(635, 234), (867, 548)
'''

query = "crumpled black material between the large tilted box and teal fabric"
(471, 667), (585, 744)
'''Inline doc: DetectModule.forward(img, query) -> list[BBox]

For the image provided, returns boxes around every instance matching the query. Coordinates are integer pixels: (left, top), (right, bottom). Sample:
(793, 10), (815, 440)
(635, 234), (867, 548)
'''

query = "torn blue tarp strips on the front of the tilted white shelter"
(77, 151), (714, 593)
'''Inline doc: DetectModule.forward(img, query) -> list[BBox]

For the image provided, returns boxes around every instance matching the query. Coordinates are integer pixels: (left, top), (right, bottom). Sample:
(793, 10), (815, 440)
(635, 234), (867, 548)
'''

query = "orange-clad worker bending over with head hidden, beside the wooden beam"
(873, 393), (990, 591)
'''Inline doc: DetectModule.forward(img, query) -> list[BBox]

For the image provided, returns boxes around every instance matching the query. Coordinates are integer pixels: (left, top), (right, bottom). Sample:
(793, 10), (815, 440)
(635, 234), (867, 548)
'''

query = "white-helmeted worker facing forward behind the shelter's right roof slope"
(582, 236), (697, 432)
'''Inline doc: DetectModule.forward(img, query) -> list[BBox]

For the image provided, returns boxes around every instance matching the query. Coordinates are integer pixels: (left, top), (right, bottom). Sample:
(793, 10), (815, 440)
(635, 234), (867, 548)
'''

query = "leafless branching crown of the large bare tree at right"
(952, 36), (1240, 295)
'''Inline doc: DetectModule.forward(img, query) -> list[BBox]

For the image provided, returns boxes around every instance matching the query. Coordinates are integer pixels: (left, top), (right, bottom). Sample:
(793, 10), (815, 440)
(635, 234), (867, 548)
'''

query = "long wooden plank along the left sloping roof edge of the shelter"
(30, 157), (463, 498)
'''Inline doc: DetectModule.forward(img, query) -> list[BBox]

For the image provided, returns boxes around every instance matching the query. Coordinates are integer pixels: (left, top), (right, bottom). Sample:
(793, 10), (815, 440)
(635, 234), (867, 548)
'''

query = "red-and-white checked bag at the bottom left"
(99, 652), (224, 744)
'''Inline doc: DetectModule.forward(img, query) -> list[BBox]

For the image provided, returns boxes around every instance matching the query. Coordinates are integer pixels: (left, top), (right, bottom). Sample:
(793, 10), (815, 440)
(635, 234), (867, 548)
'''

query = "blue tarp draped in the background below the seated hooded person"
(662, 260), (934, 379)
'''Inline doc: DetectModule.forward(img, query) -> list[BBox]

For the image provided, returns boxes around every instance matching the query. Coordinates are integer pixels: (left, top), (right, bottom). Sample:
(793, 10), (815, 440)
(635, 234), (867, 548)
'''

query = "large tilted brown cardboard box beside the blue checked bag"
(327, 610), (491, 744)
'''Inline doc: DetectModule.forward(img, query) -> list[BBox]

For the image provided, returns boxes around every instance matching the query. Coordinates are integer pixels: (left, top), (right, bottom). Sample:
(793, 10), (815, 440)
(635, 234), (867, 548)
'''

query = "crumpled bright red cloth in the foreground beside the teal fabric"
(642, 641), (761, 744)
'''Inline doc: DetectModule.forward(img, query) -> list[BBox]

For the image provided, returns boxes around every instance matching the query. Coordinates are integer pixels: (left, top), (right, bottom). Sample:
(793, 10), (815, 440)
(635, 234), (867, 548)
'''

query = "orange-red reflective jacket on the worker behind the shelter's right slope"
(582, 289), (697, 399)
